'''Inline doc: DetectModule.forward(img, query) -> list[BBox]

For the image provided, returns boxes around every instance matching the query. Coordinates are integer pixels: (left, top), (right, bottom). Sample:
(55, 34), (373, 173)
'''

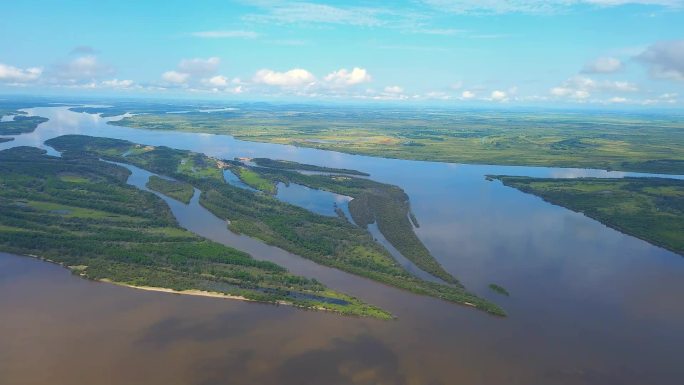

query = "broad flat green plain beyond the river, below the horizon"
(73, 105), (684, 174)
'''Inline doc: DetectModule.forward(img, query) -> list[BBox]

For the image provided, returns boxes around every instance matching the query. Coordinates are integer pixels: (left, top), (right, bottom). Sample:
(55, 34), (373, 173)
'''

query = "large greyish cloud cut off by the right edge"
(636, 40), (684, 81)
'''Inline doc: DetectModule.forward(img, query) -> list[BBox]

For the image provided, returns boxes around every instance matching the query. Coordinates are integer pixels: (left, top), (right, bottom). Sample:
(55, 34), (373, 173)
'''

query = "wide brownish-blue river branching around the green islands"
(0, 107), (684, 385)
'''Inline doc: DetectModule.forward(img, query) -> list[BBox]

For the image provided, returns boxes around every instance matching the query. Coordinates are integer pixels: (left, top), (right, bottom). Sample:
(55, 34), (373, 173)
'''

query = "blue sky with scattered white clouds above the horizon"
(0, 0), (684, 108)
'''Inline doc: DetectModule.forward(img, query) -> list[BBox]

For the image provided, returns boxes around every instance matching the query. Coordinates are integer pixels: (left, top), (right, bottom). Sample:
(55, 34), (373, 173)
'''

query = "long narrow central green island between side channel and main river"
(46, 135), (505, 316)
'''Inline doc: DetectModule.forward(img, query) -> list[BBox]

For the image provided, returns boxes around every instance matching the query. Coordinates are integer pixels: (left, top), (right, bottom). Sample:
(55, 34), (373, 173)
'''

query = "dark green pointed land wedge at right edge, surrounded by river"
(490, 175), (684, 255)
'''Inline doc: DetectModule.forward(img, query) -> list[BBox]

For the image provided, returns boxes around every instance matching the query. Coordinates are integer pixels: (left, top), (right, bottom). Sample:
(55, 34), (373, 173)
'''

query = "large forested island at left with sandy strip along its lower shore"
(0, 147), (392, 319)
